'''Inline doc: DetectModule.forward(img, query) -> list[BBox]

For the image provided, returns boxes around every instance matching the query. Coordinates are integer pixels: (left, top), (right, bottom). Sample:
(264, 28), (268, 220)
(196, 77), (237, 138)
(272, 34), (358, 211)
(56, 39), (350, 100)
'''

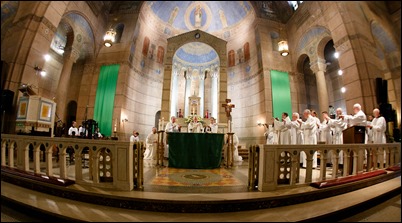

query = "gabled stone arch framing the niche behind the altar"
(161, 29), (227, 122)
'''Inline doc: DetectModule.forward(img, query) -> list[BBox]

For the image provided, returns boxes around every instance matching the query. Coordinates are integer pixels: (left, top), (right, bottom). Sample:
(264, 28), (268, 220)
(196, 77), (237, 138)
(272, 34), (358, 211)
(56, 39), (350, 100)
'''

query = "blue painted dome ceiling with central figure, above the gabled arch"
(147, 1), (253, 32)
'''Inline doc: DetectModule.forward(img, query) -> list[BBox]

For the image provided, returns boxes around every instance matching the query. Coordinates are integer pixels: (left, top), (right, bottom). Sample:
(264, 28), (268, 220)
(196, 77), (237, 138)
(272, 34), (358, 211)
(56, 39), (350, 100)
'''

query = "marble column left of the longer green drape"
(56, 47), (79, 125)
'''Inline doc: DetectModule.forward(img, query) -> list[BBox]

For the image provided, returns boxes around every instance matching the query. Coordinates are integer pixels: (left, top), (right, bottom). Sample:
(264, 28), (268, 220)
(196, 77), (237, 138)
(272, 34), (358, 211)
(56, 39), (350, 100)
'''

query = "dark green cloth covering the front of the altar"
(167, 132), (224, 169)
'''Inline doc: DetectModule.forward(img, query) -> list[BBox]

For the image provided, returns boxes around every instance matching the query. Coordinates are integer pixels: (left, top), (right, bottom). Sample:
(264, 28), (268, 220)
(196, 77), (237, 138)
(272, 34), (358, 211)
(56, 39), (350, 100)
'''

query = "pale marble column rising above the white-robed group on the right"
(310, 58), (329, 115)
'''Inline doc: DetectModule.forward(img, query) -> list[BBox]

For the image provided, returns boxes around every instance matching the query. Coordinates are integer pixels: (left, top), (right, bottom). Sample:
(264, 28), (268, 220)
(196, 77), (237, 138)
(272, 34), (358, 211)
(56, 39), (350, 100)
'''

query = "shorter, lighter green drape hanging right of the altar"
(271, 70), (292, 120)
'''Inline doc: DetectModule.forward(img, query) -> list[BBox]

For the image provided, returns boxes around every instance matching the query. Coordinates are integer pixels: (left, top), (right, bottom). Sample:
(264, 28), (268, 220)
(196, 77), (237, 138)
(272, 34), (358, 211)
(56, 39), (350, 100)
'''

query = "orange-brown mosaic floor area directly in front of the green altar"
(150, 168), (243, 187)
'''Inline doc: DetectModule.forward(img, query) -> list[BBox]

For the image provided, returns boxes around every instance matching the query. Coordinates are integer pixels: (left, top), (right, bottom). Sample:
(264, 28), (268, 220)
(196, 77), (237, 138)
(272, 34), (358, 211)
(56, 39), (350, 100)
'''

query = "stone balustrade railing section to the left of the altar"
(1, 134), (144, 190)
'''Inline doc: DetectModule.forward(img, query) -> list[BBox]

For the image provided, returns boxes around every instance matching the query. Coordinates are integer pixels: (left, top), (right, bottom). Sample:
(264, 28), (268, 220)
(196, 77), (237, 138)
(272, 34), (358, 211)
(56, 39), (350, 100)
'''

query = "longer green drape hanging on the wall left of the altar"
(94, 64), (120, 136)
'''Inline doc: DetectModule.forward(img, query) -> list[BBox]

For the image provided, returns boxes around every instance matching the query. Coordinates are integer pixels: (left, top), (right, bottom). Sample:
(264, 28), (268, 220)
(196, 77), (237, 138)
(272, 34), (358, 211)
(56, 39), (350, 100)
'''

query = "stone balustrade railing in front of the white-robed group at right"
(256, 143), (401, 191)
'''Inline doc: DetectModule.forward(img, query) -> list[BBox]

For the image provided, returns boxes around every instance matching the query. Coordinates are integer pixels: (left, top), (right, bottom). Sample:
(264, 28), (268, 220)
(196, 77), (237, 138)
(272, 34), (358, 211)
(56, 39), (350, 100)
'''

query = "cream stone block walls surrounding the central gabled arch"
(1, 1), (401, 144)
